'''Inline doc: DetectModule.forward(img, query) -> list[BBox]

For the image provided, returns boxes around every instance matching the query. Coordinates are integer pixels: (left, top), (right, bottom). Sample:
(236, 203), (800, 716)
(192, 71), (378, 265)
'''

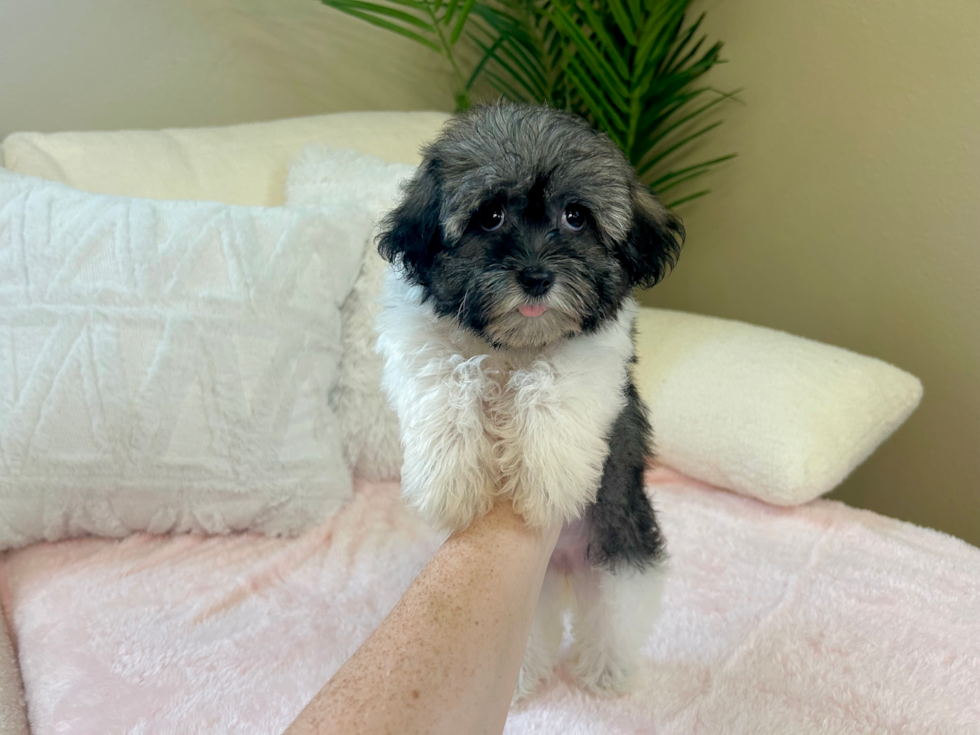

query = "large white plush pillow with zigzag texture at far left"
(0, 169), (370, 548)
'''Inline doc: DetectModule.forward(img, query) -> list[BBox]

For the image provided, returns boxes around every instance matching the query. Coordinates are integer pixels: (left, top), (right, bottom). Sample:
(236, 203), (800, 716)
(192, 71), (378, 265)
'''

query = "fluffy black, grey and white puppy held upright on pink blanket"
(378, 105), (684, 700)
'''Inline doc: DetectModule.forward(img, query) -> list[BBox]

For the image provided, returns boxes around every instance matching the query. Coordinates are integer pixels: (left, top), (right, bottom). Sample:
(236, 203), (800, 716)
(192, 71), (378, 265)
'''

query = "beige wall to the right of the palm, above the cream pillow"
(647, 0), (980, 544)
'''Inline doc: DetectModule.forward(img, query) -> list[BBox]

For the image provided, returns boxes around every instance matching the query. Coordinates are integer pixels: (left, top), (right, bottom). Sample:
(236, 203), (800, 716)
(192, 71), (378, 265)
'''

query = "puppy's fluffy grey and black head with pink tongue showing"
(379, 105), (684, 348)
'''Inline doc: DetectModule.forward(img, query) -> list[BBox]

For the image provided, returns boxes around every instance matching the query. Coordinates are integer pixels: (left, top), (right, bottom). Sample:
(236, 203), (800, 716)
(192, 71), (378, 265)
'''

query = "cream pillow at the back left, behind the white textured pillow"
(2, 112), (449, 206)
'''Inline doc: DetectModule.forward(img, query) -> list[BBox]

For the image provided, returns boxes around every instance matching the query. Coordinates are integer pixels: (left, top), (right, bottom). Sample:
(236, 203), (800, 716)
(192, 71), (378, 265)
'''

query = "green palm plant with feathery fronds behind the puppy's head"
(321, 0), (737, 206)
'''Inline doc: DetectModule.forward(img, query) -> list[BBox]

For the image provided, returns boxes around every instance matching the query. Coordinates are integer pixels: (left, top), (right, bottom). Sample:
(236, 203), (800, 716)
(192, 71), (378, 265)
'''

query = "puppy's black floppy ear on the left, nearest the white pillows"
(378, 160), (442, 283)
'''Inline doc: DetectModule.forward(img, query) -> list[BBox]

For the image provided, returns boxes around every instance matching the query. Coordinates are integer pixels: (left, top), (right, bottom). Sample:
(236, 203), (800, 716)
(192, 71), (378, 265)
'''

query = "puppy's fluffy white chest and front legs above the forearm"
(378, 272), (636, 529)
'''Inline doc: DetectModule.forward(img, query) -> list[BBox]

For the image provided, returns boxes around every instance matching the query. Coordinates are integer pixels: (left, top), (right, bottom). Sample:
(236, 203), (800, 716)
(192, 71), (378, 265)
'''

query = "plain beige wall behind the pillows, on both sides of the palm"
(0, 0), (980, 543)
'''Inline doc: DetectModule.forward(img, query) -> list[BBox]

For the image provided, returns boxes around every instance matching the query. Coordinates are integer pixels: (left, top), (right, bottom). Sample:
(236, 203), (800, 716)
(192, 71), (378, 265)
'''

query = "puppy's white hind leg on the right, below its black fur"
(569, 564), (665, 696)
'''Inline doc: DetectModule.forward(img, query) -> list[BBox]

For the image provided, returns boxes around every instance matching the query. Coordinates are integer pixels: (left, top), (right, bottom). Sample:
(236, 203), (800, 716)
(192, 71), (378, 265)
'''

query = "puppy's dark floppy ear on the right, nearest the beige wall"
(620, 183), (685, 288)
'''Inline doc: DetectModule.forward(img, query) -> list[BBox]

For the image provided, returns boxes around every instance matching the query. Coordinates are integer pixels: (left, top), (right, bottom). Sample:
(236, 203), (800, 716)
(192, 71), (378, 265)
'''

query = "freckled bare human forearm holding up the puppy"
(286, 503), (560, 735)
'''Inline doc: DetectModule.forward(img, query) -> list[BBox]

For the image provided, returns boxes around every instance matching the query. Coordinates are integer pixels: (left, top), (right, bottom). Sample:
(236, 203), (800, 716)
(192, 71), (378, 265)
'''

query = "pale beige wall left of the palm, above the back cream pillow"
(0, 0), (452, 138)
